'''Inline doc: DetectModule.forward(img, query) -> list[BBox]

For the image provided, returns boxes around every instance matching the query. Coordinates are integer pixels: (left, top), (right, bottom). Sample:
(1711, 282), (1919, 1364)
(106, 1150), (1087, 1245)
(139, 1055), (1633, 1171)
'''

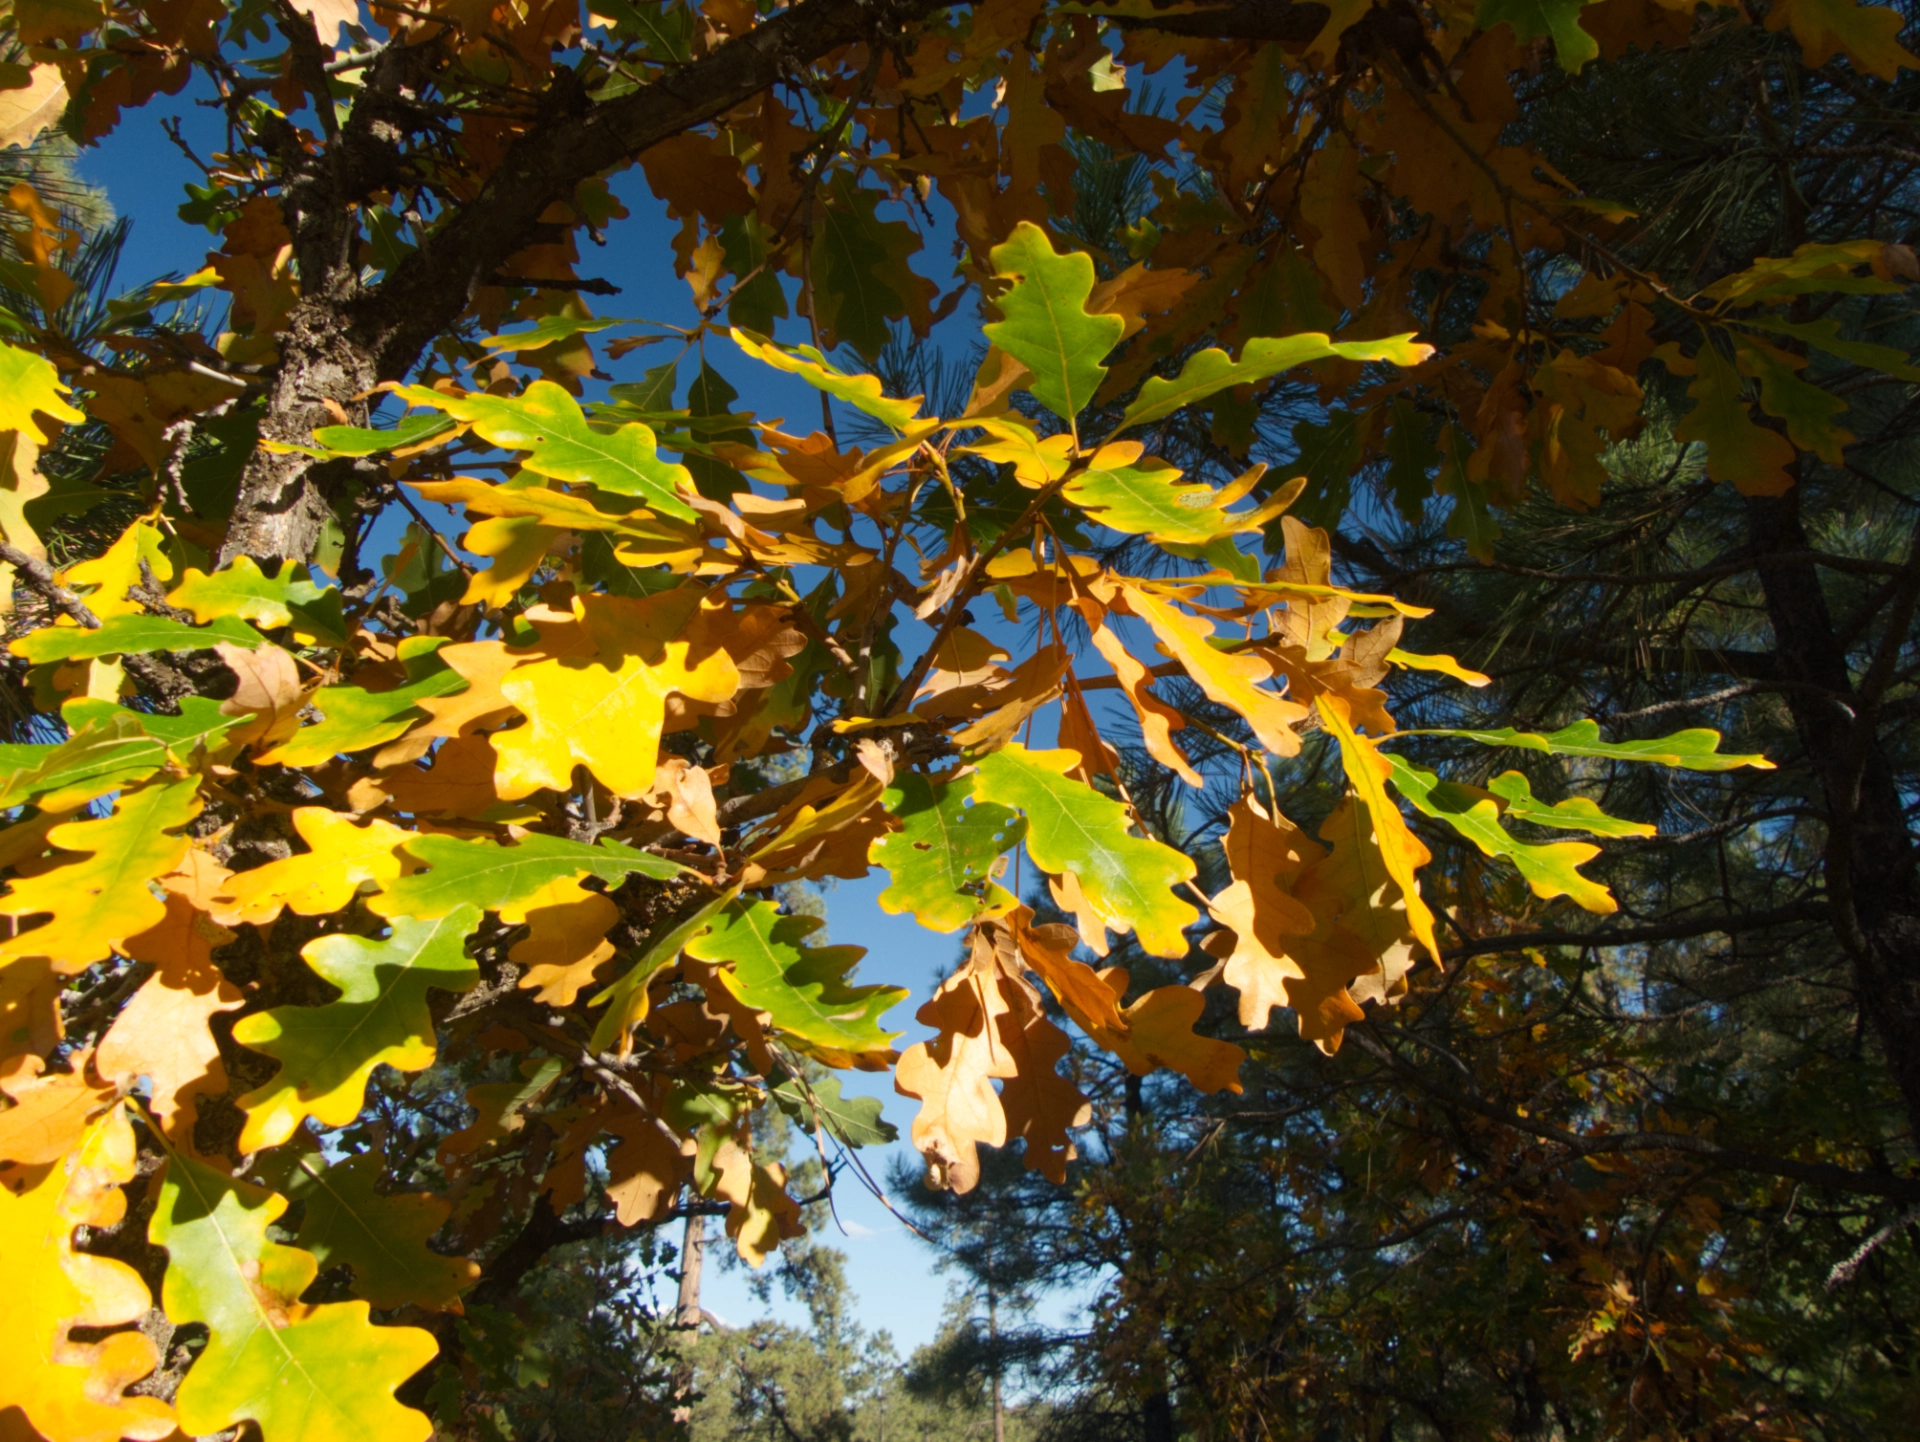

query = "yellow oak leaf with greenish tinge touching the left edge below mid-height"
(0, 778), (200, 975)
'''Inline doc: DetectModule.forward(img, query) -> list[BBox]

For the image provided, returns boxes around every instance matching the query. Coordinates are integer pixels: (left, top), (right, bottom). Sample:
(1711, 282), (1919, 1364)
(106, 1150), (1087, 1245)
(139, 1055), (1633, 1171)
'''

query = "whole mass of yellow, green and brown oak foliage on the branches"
(0, 0), (1916, 1442)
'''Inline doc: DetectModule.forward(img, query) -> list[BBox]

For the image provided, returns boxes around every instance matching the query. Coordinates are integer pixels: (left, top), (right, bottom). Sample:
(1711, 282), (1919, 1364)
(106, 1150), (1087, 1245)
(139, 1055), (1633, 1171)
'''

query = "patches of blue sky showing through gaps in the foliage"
(79, 73), (1098, 1356)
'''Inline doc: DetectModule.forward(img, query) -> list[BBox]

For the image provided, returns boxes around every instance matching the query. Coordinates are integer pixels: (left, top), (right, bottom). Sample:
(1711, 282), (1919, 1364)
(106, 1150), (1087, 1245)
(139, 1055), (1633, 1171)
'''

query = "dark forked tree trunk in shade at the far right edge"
(1747, 488), (1920, 1133)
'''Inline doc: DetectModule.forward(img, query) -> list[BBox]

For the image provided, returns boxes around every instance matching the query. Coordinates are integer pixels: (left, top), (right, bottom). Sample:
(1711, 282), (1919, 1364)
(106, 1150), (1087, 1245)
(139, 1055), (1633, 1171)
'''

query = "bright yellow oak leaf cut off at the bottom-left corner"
(0, 1106), (175, 1442)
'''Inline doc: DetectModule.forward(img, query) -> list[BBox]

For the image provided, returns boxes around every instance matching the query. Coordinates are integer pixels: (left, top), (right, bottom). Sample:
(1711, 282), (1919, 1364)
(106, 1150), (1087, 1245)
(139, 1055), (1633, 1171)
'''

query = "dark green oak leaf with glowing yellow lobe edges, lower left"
(234, 902), (480, 1152)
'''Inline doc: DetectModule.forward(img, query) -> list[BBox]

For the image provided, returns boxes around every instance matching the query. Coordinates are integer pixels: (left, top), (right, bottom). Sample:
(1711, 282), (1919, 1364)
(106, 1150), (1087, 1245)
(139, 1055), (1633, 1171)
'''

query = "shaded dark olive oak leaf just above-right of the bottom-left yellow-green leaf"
(259, 1152), (480, 1311)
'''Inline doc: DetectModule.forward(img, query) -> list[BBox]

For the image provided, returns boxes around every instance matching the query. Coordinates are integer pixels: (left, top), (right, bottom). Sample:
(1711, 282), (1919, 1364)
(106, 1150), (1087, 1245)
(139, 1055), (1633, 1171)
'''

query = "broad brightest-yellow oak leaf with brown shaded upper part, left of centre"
(492, 588), (739, 801)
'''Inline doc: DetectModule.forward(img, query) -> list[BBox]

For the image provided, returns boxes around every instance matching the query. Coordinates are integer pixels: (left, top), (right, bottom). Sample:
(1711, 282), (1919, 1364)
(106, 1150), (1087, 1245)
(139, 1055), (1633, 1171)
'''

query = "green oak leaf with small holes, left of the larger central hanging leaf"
(866, 772), (1027, 931)
